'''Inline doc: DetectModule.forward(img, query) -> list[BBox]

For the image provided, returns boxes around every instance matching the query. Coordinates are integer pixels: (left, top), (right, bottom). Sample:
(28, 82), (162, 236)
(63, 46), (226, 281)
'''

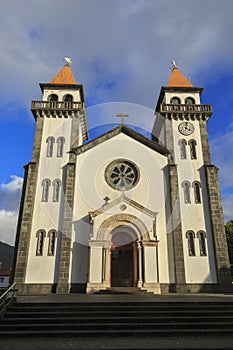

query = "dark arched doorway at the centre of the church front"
(111, 228), (136, 287)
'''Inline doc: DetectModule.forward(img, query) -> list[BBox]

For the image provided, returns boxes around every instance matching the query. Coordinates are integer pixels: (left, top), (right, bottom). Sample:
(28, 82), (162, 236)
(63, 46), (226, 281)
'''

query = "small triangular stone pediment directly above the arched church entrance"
(89, 194), (157, 218)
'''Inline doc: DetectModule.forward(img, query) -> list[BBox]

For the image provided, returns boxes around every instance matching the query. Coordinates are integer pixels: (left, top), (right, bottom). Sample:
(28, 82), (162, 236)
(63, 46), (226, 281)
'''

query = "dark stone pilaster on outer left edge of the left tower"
(14, 162), (38, 283)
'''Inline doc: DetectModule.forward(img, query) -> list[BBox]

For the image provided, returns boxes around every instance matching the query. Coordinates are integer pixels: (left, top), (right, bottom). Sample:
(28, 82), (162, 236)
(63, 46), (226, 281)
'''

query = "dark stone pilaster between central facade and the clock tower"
(169, 164), (187, 293)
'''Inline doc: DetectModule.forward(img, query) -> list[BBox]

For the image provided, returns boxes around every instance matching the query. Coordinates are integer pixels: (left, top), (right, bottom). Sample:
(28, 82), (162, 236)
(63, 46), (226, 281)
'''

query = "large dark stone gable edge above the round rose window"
(71, 124), (169, 156)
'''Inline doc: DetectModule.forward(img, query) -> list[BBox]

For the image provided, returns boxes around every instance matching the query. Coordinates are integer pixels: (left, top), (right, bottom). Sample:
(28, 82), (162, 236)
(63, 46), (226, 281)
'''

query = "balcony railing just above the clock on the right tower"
(160, 103), (212, 114)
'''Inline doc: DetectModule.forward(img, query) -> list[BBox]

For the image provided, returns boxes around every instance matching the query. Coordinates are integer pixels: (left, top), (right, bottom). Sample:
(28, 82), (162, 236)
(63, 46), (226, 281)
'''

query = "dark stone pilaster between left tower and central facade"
(56, 161), (76, 294)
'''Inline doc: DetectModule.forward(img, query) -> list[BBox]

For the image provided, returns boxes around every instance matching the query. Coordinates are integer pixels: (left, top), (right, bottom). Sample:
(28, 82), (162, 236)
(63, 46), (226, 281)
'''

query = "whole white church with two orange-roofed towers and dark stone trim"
(12, 62), (232, 294)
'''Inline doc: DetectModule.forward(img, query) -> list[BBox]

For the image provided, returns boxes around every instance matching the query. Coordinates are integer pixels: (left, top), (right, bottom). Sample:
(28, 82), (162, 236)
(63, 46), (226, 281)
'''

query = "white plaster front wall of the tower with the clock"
(172, 118), (216, 283)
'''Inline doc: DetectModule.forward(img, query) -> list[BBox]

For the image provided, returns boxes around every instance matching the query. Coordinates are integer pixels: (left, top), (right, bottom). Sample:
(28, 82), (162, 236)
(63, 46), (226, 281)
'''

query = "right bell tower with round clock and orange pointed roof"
(152, 64), (231, 292)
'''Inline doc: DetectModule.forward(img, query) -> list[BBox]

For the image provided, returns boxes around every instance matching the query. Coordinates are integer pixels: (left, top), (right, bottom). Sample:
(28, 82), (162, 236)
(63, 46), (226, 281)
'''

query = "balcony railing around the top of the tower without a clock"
(31, 101), (85, 111)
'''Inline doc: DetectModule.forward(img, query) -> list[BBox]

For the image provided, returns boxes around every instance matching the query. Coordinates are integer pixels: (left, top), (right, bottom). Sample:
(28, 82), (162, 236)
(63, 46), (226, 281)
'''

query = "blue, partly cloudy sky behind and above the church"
(0, 0), (233, 244)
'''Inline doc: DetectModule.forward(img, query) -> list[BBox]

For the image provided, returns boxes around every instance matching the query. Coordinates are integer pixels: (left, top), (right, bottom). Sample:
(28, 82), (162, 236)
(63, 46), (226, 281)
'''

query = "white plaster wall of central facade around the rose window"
(73, 134), (170, 283)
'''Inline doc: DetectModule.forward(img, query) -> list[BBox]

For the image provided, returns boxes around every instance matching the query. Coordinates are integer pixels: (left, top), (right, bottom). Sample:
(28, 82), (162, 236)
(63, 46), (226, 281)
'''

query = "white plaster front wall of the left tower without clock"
(26, 117), (72, 283)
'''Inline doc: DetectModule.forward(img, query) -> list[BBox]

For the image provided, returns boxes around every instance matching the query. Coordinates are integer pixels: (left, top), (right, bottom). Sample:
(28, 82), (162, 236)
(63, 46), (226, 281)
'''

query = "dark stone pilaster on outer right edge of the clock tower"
(205, 165), (233, 292)
